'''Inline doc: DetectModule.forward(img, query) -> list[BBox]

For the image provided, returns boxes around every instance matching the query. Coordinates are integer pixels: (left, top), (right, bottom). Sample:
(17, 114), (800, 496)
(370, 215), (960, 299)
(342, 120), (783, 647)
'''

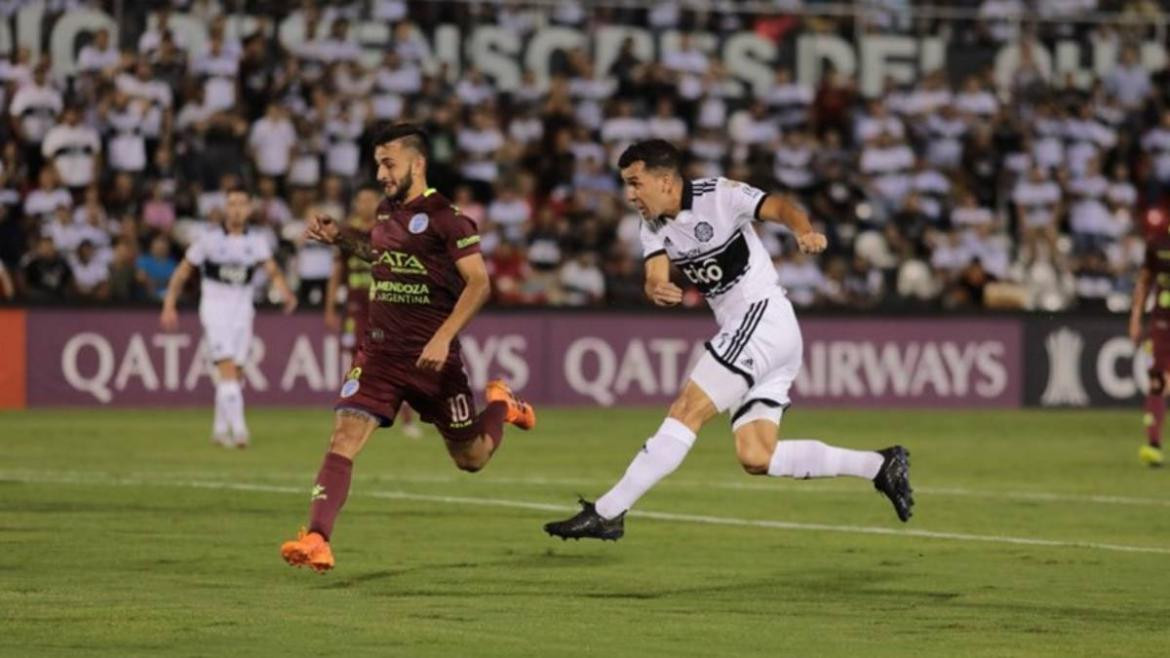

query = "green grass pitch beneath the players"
(0, 409), (1170, 658)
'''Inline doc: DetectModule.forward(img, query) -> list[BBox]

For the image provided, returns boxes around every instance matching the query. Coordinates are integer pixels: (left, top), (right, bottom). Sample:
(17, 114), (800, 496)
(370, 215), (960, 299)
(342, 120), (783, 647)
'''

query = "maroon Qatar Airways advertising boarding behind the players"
(27, 310), (1023, 407)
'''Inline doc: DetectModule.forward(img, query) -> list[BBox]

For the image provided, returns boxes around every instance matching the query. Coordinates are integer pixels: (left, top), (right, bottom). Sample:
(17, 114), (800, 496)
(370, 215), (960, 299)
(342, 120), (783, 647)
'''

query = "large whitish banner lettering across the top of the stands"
(0, 0), (1166, 95)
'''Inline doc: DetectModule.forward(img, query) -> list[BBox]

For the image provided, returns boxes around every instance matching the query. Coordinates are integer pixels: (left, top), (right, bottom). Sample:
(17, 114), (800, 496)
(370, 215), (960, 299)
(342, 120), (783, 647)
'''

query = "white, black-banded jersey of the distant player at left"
(184, 228), (273, 320)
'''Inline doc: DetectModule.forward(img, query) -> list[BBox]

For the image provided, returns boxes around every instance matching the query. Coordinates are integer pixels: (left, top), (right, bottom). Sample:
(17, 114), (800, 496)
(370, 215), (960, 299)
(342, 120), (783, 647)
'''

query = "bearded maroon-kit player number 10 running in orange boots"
(281, 124), (536, 571)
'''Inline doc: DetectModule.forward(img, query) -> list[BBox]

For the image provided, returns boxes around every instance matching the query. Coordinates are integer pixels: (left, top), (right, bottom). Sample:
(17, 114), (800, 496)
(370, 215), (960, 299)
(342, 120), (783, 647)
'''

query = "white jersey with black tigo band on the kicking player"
(641, 178), (784, 325)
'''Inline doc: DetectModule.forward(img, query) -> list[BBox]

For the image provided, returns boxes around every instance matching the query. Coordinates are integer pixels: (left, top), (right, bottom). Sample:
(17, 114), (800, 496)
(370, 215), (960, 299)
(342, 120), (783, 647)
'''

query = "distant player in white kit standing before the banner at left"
(161, 190), (296, 447)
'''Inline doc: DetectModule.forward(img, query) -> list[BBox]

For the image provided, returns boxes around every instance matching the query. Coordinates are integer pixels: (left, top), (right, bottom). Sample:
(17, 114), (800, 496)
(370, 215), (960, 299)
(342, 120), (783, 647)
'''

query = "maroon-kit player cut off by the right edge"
(1129, 213), (1170, 466)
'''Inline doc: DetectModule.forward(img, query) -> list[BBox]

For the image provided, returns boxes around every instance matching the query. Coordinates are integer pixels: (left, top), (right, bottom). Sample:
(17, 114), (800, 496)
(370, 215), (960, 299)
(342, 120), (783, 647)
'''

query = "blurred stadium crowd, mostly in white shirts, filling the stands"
(0, 0), (1170, 310)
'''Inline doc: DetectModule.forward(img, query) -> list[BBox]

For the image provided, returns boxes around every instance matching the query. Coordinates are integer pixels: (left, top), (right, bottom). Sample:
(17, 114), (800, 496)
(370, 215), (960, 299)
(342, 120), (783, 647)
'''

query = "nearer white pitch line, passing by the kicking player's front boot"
(0, 473), (1170, 555)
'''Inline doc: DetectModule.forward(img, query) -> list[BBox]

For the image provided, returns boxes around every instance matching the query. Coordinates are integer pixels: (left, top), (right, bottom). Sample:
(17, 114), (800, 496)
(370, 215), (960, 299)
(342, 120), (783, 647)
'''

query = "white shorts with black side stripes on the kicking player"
(690, 295), (804, 430)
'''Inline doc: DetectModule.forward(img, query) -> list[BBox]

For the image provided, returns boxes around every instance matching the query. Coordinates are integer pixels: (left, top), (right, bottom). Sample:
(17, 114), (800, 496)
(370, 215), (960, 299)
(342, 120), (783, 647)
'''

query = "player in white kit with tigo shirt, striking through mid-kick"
(544, 139), (914, 540)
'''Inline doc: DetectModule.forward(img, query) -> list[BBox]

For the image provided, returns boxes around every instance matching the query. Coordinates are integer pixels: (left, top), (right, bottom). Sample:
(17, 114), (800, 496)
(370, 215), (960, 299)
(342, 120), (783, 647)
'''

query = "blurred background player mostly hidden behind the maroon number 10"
(325, 186), (422, 439)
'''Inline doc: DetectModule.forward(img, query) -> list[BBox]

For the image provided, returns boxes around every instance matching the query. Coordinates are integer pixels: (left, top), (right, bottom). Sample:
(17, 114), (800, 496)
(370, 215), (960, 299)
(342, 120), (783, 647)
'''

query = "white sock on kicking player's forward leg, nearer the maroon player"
(596, 418), (695, 519)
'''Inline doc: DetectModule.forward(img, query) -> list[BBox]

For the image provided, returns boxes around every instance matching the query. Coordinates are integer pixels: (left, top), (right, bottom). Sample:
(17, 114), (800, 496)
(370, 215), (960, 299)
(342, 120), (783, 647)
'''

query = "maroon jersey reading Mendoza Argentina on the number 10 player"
(363, 190), (480, 358)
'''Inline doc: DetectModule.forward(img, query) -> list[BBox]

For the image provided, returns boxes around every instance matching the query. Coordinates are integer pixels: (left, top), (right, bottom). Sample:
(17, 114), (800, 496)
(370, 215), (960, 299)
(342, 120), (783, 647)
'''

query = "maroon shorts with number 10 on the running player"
(333, 349), (480, 443)
